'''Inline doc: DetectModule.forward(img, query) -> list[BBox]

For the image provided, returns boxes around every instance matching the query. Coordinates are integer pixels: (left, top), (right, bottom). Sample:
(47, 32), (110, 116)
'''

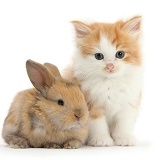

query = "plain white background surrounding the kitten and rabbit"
(0, 0), (160, 160)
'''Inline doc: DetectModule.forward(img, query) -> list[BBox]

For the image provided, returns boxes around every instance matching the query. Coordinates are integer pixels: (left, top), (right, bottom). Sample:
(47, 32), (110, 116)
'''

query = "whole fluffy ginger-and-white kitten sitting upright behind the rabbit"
(65, 16), (142, 146)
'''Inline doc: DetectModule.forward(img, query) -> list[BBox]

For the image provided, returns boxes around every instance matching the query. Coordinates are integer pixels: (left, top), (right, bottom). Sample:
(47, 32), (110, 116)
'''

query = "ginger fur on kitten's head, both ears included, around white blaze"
(72, 16), (141, 65)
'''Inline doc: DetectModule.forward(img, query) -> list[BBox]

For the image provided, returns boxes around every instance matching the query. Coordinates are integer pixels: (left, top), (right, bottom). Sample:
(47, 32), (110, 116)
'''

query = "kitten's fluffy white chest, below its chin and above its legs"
(82, 78), (137, 115)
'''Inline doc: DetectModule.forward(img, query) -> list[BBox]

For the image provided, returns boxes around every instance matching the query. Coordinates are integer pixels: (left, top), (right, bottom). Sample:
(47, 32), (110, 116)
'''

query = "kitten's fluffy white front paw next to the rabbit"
(87, 136), (114, 147)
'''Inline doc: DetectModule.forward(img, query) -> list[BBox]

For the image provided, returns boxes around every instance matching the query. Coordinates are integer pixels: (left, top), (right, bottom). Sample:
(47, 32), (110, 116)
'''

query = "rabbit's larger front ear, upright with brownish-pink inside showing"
(26, 60), (55, 95)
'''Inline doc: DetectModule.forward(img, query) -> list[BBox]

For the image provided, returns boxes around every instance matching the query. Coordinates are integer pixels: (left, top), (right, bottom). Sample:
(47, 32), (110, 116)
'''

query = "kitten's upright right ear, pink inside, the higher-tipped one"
(123, 16), (142, 38)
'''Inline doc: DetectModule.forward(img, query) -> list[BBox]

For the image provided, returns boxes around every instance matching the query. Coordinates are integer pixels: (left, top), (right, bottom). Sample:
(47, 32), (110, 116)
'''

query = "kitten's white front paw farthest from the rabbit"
(113, 136), (136, 146)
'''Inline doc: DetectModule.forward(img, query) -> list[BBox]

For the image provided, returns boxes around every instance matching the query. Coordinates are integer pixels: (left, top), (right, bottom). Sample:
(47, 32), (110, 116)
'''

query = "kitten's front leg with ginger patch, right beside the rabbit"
(87, 108), (114, 146)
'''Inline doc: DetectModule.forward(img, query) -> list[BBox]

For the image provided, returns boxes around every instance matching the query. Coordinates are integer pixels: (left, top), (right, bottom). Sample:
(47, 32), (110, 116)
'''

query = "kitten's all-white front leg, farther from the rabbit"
(112, 107), (137, 146)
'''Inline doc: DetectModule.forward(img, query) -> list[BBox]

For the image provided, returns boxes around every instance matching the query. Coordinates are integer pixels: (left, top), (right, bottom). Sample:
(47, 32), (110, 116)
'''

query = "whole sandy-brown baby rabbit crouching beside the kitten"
(2, 60), (88, 149)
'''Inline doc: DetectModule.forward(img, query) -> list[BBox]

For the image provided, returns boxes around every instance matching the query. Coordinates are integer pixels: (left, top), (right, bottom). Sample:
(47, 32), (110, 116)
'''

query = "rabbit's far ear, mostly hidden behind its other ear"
(44, 63), (62, 80)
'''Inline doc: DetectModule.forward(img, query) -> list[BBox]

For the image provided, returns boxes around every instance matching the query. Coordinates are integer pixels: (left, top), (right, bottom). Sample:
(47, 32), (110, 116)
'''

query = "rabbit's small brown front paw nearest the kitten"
(64, 140), (82, 149)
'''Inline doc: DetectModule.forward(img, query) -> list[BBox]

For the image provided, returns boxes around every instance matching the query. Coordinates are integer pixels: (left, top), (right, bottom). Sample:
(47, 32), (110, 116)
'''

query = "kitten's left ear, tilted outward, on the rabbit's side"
(72, 21), (91, 38)
